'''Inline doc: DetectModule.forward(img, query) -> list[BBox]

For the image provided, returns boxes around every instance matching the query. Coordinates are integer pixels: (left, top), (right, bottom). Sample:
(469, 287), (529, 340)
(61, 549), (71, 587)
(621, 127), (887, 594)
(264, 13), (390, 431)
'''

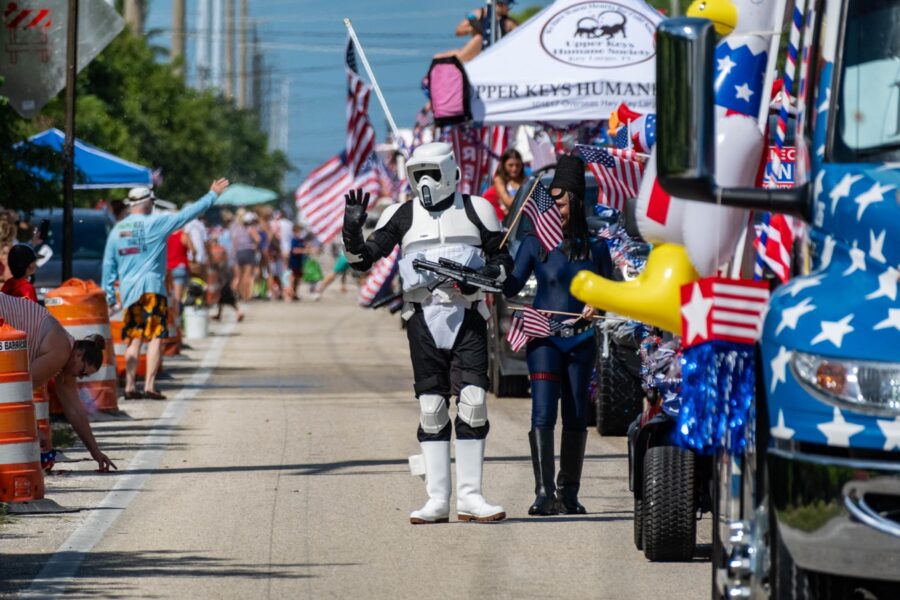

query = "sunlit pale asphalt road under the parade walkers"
(0, 291), (709, 600)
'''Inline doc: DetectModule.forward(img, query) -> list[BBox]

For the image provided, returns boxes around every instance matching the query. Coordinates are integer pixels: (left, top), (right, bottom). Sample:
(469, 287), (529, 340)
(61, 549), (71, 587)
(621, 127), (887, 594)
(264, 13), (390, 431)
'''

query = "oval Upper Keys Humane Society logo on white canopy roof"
(541, 2), (656, 69)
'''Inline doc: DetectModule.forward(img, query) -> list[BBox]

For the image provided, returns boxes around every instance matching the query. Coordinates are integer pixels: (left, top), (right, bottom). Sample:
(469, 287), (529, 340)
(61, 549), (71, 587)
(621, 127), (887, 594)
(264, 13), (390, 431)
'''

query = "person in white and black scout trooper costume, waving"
(343, 143), (512, 524)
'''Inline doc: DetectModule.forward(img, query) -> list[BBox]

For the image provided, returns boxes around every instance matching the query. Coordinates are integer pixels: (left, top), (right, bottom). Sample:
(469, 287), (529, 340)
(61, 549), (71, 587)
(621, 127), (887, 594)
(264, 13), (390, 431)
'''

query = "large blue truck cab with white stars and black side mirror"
(651, 0), (900, 598)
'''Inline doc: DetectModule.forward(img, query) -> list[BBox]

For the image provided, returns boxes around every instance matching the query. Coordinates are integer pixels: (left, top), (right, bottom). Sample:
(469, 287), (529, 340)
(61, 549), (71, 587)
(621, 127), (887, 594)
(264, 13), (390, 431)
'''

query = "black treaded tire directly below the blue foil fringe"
(643, 446), (698, 561)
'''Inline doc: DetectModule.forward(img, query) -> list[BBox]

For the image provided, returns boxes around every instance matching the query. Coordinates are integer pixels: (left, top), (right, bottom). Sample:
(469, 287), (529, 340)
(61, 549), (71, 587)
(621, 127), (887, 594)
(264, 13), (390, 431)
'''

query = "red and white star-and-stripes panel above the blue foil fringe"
(681, 277), (769, 348)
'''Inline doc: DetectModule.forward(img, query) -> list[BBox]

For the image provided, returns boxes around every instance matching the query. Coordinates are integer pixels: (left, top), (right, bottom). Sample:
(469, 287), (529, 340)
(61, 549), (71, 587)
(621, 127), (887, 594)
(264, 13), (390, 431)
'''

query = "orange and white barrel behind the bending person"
(44, 279), (119, 412)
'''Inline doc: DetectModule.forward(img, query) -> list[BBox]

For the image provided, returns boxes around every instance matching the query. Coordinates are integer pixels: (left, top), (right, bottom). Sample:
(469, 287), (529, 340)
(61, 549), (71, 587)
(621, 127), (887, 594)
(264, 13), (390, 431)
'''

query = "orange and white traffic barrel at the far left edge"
(0, 319), (44, 502)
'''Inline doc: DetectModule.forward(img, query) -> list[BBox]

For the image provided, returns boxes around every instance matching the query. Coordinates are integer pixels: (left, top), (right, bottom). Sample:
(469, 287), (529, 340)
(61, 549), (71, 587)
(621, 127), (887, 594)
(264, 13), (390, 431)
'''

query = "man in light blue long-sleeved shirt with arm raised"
(103, 179), (228, 400)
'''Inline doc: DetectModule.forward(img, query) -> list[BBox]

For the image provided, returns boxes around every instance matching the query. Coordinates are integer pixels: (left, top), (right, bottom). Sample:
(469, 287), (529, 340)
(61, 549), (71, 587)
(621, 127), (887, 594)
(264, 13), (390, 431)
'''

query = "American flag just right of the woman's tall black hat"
(576, 145), (644, 210)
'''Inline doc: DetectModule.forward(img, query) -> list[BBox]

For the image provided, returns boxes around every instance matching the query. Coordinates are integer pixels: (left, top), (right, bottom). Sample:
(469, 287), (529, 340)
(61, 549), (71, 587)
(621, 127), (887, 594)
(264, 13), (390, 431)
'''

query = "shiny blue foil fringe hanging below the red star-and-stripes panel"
(676, 340), (756, 455)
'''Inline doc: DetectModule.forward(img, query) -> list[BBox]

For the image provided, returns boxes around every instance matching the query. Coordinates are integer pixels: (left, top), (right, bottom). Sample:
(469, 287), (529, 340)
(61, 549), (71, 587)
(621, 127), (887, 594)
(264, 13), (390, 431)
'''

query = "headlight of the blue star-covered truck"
(791, 352), (900, 416)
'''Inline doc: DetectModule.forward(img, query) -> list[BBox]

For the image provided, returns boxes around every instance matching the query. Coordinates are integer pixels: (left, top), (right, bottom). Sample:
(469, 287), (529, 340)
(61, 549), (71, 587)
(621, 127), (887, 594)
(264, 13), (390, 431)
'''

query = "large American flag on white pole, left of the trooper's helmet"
(294, 41), (381, 243)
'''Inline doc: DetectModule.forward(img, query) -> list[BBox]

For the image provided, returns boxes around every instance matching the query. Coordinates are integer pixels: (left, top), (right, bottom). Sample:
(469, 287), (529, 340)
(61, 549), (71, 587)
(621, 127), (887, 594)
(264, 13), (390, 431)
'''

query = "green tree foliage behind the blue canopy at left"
(0, 31), (290, 208)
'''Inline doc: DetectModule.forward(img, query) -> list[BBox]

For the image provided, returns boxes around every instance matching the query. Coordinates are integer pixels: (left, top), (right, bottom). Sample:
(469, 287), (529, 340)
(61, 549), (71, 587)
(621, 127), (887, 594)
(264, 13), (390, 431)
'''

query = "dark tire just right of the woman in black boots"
(592, 349), (644, 435)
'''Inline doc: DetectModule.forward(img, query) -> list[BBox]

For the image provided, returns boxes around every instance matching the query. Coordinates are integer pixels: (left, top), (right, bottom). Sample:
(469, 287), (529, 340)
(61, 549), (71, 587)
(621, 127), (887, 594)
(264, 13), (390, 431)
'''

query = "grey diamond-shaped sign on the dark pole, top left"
(0, 0), (125, 119)
